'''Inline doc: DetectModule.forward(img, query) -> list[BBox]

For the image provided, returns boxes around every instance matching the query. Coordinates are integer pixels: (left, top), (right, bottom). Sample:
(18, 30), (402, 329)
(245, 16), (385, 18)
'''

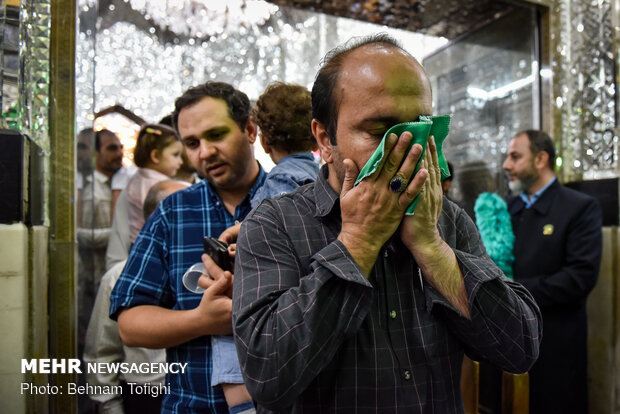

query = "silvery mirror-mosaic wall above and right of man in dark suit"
(551, 0), (618, 181)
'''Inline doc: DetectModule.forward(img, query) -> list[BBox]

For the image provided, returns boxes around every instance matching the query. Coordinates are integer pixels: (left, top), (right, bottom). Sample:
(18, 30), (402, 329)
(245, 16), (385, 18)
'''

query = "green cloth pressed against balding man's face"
(355, 115), (450, 215)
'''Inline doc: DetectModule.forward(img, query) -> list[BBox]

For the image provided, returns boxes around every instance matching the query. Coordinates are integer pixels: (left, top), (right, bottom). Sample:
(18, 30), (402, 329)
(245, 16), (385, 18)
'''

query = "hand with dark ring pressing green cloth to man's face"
(338, 132), (428, 277)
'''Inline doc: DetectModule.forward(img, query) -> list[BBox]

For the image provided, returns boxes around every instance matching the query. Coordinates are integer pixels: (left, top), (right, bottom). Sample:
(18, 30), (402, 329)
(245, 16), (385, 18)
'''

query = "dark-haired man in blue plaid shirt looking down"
(110, 82), (266, 413)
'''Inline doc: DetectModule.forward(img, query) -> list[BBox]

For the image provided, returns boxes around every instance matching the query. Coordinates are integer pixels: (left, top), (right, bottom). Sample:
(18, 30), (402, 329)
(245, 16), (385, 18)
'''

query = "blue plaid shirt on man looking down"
(110, 168), (266, 413)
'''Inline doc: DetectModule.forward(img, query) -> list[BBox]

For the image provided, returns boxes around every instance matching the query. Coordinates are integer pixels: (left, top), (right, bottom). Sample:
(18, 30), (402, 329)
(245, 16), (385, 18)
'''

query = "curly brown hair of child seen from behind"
(253, 82), (317, 153)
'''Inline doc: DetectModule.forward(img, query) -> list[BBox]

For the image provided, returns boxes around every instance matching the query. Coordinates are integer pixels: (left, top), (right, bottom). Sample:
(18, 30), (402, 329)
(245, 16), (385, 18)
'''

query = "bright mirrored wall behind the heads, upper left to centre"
(76, 0), (447, 160)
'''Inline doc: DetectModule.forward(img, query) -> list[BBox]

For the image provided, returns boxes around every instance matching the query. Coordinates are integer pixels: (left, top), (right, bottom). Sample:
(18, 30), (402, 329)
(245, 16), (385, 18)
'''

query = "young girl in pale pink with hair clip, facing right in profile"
(106, 124), (183, 269)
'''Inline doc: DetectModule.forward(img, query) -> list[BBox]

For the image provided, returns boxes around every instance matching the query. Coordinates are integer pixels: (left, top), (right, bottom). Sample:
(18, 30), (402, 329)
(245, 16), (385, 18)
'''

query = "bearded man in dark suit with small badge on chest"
(503, 130), (602, 414)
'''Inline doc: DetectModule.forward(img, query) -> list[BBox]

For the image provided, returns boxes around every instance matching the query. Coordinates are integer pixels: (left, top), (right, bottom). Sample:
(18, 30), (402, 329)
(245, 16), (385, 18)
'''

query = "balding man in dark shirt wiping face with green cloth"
(228, 35), (541, 414)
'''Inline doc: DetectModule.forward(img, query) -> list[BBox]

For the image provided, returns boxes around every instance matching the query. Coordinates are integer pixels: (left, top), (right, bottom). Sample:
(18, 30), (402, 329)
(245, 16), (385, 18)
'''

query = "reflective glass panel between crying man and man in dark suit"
(424, 8), (540, 217)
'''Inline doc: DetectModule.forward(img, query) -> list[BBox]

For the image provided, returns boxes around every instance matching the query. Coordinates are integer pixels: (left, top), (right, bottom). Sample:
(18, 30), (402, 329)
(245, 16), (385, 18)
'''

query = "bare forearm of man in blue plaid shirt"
(118, 305), (226, 348)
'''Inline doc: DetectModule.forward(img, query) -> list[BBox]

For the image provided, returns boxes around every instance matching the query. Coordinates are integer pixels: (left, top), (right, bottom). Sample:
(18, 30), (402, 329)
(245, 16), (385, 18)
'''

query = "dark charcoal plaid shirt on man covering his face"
(233, 164), (542, 414)
